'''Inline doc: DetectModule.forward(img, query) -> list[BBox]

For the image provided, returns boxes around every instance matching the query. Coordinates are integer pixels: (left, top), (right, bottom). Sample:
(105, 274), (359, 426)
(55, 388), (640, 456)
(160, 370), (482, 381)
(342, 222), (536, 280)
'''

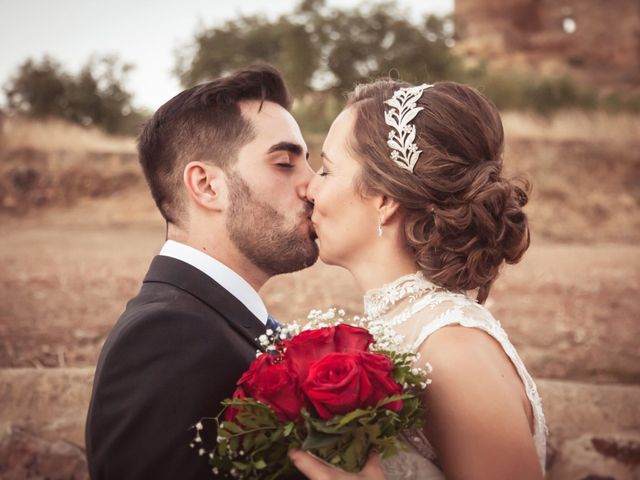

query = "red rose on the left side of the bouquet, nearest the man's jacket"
(229, 353), (303, 421)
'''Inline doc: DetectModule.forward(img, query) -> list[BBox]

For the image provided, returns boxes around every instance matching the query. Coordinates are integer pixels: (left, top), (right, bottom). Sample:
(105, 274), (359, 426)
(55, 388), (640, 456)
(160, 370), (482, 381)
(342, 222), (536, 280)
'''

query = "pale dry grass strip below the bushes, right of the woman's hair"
(502, 111), (640, 142)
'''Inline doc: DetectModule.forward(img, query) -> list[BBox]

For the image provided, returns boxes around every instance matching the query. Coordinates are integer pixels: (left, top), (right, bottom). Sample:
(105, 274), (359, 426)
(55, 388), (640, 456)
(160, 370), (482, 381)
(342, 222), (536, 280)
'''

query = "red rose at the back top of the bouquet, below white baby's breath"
(286, 325), (374, 383)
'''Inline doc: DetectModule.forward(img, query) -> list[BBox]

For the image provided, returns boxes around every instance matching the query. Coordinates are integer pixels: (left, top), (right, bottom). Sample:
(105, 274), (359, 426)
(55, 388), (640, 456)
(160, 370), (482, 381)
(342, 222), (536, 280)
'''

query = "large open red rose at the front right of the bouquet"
(302, 351), (402, 420)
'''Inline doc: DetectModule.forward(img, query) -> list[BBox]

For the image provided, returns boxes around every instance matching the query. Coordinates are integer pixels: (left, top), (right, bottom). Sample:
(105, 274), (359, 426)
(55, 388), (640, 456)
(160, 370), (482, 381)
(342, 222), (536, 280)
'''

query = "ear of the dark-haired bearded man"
(182, 162), (226, 211)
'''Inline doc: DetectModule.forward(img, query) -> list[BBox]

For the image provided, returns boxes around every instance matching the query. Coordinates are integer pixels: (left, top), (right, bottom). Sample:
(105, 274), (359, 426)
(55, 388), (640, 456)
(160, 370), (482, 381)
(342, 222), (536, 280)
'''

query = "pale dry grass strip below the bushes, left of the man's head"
(0, 117), (135, 153)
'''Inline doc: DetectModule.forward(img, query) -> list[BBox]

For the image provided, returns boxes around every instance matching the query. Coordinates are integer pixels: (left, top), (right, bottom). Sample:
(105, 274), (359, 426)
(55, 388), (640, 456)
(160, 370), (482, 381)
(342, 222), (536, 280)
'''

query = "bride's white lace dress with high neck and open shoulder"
(364, 272), (547, 480)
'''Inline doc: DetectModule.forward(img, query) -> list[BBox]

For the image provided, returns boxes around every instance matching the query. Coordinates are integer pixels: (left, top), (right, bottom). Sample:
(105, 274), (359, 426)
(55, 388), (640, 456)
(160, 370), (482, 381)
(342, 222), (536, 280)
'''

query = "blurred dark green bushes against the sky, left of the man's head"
(4, 56), (143, 133)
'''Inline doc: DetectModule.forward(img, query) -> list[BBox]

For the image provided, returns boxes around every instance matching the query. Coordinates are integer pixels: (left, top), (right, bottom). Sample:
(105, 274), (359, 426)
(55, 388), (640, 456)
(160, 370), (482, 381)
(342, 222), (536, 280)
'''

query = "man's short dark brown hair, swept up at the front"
(138, 65), (291, 225)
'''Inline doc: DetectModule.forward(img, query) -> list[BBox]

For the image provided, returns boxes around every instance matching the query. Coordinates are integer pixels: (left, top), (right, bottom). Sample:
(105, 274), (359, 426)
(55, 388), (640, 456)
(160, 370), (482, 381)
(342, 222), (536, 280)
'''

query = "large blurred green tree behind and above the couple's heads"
(175, 0), (459, 96)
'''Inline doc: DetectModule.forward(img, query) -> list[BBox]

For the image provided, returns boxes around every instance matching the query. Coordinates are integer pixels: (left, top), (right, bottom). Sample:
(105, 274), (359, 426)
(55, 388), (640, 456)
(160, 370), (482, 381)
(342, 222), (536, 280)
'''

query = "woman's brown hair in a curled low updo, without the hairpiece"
(347, 80), (530, 303)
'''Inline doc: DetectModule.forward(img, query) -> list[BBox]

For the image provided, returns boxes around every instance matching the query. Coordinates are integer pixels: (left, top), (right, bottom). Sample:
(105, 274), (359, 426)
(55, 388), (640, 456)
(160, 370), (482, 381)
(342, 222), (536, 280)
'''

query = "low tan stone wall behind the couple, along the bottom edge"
(0, 367), (640, 480)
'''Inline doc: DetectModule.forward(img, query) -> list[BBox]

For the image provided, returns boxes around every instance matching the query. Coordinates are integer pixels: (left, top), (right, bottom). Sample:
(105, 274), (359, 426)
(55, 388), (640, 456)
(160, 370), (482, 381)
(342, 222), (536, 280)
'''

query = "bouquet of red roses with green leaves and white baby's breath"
(191, 309), (430, 479)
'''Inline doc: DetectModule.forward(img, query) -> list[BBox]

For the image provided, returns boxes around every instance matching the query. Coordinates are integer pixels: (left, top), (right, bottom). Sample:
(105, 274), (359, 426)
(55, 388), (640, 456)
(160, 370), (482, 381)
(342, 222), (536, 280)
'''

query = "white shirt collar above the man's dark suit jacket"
(160, 240), (268, 325)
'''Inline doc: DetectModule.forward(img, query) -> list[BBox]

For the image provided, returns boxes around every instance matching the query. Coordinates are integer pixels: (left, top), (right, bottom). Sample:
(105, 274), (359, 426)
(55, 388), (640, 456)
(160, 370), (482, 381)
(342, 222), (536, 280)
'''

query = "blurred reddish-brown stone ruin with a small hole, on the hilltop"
(455, 0), (640, 90)
